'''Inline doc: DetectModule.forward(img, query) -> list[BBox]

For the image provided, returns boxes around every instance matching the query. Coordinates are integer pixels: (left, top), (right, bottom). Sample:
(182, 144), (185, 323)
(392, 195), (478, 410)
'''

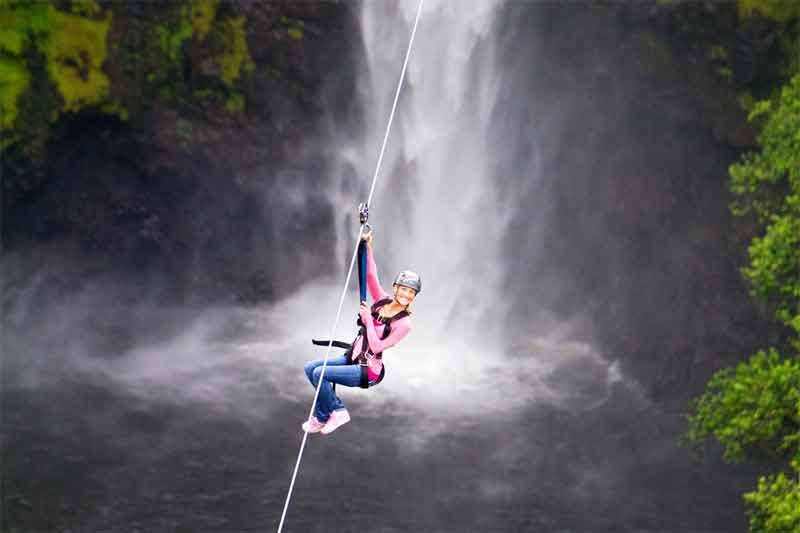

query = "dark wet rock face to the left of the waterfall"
(3, 1), (357, 301)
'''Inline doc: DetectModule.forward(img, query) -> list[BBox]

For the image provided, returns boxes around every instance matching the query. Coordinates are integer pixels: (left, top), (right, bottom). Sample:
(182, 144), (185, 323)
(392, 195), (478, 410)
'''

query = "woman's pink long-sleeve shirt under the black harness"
(352, 246), (411, 380)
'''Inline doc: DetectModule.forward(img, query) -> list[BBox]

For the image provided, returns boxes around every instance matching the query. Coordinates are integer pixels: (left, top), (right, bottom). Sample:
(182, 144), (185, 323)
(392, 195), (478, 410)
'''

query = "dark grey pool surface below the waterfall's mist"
(3, 367), (748, 532)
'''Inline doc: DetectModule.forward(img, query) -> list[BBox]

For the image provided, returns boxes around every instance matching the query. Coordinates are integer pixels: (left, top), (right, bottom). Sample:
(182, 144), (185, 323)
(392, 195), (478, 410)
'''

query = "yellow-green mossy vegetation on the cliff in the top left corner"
(0, 0), (254, 181)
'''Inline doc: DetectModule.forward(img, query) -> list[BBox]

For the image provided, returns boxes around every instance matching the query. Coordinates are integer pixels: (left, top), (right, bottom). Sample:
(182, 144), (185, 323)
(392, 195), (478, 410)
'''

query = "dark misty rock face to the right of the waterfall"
(496, 3), (777, 400)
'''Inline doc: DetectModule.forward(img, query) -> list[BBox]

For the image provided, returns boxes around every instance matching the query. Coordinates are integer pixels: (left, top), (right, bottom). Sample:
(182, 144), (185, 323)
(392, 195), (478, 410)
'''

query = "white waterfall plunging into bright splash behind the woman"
(326, 1), (632, 410)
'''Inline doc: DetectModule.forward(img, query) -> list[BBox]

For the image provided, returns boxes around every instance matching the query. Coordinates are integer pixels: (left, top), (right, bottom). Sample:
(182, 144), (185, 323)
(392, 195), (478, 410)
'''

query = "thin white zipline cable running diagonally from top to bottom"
(278, 0), (425, 533)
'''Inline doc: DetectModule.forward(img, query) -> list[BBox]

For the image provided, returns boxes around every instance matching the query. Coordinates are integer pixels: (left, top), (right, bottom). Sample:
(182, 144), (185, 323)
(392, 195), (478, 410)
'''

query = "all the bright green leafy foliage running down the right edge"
(687, 65), (800, 533)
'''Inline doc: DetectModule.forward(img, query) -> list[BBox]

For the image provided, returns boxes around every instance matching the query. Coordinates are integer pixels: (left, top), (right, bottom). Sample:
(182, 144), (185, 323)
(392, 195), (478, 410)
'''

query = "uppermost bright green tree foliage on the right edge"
(730, 75), (800, 334)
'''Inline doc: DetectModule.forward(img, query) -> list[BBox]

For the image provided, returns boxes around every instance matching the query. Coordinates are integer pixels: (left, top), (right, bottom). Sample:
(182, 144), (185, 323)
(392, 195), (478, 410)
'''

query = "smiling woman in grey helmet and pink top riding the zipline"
(303, 232), (422, 435)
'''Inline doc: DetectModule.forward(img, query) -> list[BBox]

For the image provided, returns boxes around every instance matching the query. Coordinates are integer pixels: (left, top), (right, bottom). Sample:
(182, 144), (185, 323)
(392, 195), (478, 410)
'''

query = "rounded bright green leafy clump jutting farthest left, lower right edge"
(687, 349), (800, 462)
